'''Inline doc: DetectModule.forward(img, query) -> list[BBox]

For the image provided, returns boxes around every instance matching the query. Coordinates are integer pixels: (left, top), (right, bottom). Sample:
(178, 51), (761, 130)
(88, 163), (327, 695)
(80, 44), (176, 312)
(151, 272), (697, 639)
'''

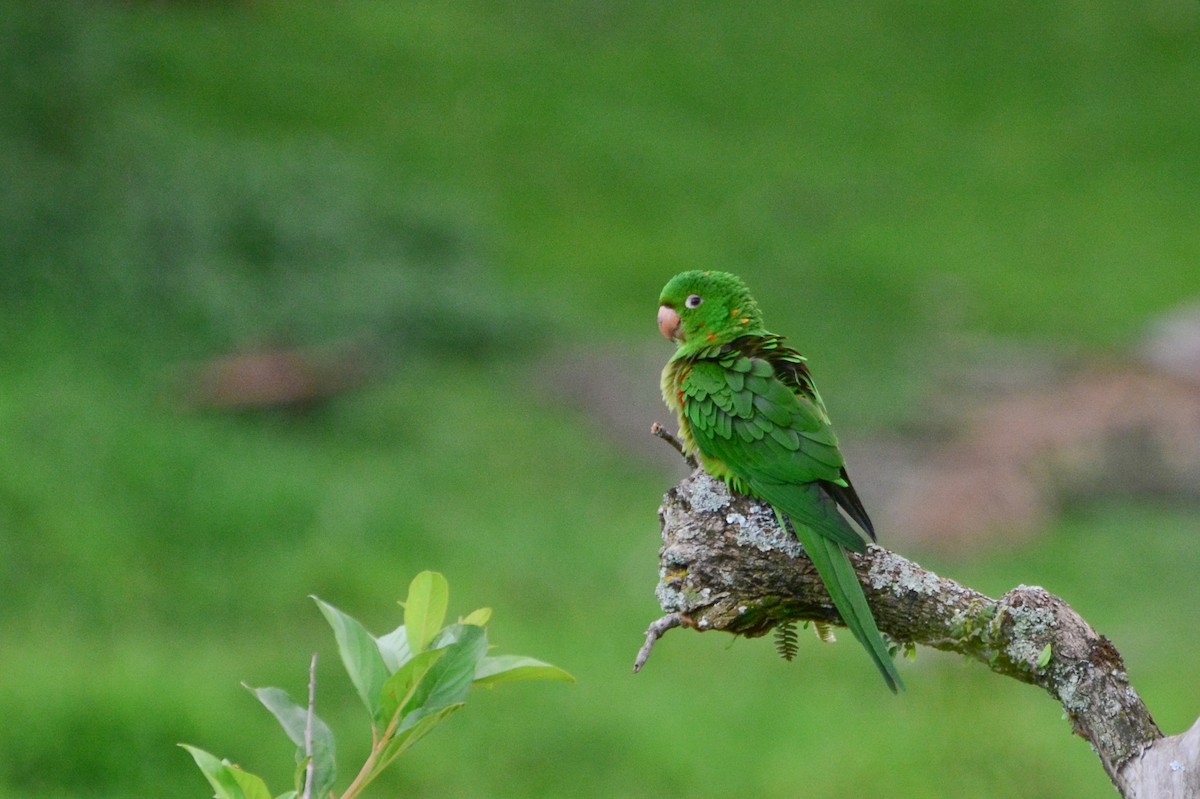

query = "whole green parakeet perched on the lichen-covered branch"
(659, 271), (904, 691)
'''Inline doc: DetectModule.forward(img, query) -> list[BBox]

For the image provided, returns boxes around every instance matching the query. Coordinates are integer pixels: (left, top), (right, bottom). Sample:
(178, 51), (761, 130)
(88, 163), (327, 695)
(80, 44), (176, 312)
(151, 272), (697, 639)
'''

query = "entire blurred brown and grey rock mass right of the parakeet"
(873, 298), (1200, 547)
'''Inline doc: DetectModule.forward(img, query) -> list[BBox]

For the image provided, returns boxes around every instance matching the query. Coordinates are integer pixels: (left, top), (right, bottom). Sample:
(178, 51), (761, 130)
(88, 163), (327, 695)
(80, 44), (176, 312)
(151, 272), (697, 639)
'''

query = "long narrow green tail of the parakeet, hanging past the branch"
(779, 515), (904, 693)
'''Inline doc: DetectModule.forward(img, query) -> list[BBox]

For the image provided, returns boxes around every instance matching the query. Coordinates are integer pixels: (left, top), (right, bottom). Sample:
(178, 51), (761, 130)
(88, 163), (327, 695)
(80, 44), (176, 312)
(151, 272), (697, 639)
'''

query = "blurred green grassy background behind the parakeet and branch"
(0, 0), (1200, 798)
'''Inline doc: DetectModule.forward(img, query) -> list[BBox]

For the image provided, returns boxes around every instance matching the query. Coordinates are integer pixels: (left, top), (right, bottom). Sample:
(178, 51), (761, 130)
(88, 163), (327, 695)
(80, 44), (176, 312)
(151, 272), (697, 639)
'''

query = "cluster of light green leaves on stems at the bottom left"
(181, 571), (575, 799)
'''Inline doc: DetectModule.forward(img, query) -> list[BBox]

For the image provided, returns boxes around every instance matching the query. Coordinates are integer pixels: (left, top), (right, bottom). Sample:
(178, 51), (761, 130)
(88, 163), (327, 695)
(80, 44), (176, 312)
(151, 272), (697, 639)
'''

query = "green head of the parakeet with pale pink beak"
(659, 271), (763, 349)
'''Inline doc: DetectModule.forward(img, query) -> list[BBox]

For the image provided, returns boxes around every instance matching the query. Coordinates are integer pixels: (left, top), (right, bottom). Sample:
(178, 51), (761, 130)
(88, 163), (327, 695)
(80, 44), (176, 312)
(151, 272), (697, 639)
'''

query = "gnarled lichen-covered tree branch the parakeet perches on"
(635, 470), (1200, 799)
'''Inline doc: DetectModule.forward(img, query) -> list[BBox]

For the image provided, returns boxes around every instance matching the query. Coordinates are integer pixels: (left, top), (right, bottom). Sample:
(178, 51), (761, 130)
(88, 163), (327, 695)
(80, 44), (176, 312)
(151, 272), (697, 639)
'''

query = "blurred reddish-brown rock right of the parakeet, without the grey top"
(873, 364), (1200, 546)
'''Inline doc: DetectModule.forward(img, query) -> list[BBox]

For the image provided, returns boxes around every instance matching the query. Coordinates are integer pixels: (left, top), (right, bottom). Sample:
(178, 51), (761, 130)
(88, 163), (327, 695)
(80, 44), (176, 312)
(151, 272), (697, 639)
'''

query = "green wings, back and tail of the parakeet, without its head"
(677, 336), (904, 691)
